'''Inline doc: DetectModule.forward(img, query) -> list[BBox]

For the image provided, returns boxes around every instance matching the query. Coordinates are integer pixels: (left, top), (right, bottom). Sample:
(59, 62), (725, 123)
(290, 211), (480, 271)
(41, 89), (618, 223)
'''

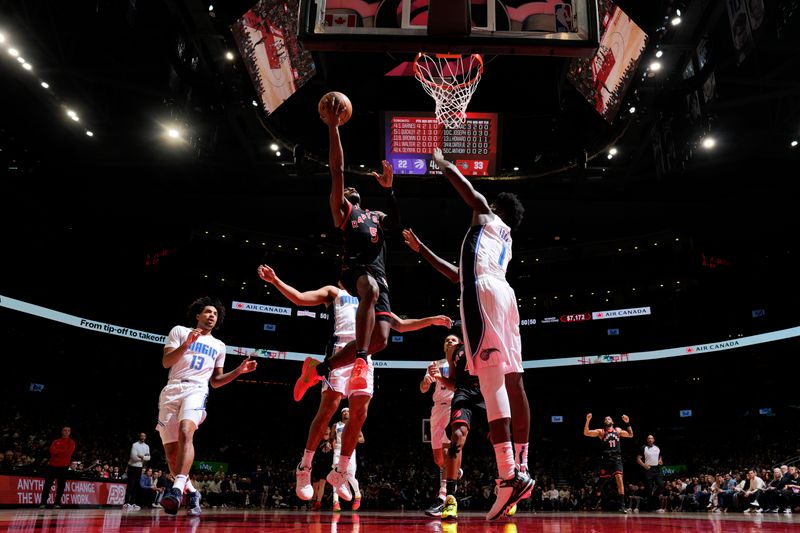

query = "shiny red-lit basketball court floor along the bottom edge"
(0, 509), (798, 533)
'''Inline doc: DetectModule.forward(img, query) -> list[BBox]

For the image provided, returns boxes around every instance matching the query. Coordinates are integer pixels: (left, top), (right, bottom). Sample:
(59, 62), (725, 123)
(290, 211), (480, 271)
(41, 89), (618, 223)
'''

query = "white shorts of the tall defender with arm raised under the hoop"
(461, 277), (523, 378)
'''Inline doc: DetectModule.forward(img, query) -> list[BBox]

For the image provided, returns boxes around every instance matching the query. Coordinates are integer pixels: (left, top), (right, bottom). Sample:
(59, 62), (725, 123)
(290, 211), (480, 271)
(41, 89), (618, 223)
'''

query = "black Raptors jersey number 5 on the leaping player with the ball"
(339, 198), (386, 274)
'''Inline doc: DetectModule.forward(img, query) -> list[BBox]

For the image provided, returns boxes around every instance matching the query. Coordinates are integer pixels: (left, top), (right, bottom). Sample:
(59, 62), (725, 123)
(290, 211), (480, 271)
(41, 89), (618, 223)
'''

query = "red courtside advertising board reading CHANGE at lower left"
(0, 476), (125, 506)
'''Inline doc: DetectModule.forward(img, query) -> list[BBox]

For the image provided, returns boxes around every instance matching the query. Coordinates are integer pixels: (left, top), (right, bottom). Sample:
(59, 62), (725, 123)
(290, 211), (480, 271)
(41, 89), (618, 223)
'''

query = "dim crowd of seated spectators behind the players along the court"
(0, 394), (800, 514)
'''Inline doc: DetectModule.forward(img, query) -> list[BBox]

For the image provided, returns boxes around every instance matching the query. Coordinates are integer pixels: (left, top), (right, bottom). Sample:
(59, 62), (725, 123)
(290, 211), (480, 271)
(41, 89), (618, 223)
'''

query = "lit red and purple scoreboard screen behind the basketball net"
(385, 111), (498, 177)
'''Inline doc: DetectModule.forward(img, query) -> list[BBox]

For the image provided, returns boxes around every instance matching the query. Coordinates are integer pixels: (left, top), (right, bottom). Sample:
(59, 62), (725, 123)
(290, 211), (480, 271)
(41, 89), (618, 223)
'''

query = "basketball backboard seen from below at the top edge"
(299, 0), (599, 57)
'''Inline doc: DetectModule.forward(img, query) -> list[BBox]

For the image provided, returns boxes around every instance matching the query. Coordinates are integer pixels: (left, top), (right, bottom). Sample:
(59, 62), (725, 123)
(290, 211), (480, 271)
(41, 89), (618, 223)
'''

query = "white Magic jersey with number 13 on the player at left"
(164, 326), (225, 383)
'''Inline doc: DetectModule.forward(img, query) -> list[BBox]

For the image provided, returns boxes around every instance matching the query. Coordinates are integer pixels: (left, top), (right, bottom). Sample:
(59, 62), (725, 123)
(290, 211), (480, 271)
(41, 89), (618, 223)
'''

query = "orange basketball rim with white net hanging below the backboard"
(414, 52), (483, 129)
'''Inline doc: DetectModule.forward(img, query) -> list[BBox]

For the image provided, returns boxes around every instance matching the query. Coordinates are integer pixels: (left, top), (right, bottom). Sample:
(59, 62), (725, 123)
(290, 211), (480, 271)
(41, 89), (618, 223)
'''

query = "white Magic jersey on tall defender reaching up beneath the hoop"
(459, 215), (511, 285)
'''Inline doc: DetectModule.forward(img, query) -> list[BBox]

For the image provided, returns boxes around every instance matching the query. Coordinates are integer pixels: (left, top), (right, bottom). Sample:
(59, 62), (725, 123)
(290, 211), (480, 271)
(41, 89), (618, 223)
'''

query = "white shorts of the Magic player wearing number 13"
(156, 381), (208, 444)
